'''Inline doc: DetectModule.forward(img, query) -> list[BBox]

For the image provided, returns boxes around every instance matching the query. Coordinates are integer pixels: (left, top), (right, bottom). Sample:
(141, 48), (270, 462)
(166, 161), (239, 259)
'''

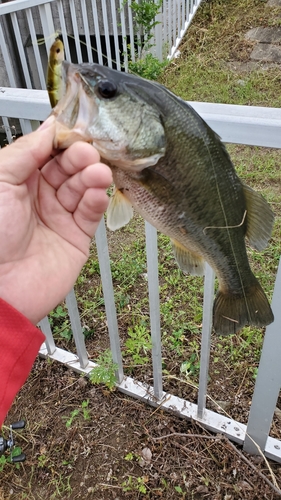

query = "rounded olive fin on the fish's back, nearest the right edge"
(243, 184), (274, 250)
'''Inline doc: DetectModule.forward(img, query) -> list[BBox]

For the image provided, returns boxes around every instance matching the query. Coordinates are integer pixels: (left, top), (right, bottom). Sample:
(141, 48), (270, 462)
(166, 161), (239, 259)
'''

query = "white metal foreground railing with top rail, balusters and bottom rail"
(0, 88), (281, 463)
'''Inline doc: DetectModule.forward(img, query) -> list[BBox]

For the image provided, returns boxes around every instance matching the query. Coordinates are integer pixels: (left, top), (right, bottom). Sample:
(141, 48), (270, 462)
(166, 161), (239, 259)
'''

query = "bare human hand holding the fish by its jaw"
(0, 117), (112, 324)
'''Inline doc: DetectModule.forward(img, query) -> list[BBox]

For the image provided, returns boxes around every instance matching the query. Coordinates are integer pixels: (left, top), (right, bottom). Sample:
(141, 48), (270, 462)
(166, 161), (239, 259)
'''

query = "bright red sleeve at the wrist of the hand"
(0, 299), (45, 428)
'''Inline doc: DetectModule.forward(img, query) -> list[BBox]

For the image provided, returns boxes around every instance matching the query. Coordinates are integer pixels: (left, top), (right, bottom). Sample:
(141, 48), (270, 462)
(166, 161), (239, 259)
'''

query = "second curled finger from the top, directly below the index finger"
(57, 163), (112, 212)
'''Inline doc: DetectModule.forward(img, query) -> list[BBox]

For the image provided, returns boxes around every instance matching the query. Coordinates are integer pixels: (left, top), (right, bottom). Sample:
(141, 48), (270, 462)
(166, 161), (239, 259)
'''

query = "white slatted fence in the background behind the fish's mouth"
(0, 0), (201, 89)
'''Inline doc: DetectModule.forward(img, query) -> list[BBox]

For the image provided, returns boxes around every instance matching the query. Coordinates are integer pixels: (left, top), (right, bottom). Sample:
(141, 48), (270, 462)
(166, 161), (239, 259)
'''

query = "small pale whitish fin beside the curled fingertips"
(107, 188), (134, 231)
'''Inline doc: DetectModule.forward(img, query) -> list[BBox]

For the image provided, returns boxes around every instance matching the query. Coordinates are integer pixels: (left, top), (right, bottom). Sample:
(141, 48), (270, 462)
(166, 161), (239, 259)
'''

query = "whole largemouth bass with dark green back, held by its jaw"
(50, 62), (274, 335)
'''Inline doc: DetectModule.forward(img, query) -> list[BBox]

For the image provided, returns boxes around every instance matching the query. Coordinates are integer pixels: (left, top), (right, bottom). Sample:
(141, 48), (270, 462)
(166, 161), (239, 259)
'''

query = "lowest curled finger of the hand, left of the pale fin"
(73, 188), (109, 238)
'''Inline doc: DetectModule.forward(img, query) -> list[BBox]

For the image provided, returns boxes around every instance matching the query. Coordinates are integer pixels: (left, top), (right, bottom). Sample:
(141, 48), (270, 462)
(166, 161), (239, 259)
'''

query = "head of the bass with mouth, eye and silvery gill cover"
(53, 62), (166, 171)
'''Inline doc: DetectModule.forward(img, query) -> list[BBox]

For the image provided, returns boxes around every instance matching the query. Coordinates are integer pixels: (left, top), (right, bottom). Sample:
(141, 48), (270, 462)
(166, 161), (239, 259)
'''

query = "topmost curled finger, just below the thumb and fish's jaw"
(41, 141), (100, 189)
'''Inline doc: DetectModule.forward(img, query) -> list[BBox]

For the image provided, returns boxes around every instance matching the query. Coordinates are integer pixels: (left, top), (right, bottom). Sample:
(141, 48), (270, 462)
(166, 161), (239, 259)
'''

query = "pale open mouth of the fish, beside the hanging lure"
(52, 62), (98, 149)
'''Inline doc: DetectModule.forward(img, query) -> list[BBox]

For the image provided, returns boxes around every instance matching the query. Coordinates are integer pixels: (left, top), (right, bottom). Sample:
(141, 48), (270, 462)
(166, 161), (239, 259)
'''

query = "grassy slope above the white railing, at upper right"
(161, 0), (281, 107)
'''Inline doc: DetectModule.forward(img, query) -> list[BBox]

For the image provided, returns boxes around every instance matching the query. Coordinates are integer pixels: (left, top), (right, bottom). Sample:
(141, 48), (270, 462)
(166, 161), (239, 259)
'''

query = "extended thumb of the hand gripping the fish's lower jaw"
(0, 116), (55, 185)
